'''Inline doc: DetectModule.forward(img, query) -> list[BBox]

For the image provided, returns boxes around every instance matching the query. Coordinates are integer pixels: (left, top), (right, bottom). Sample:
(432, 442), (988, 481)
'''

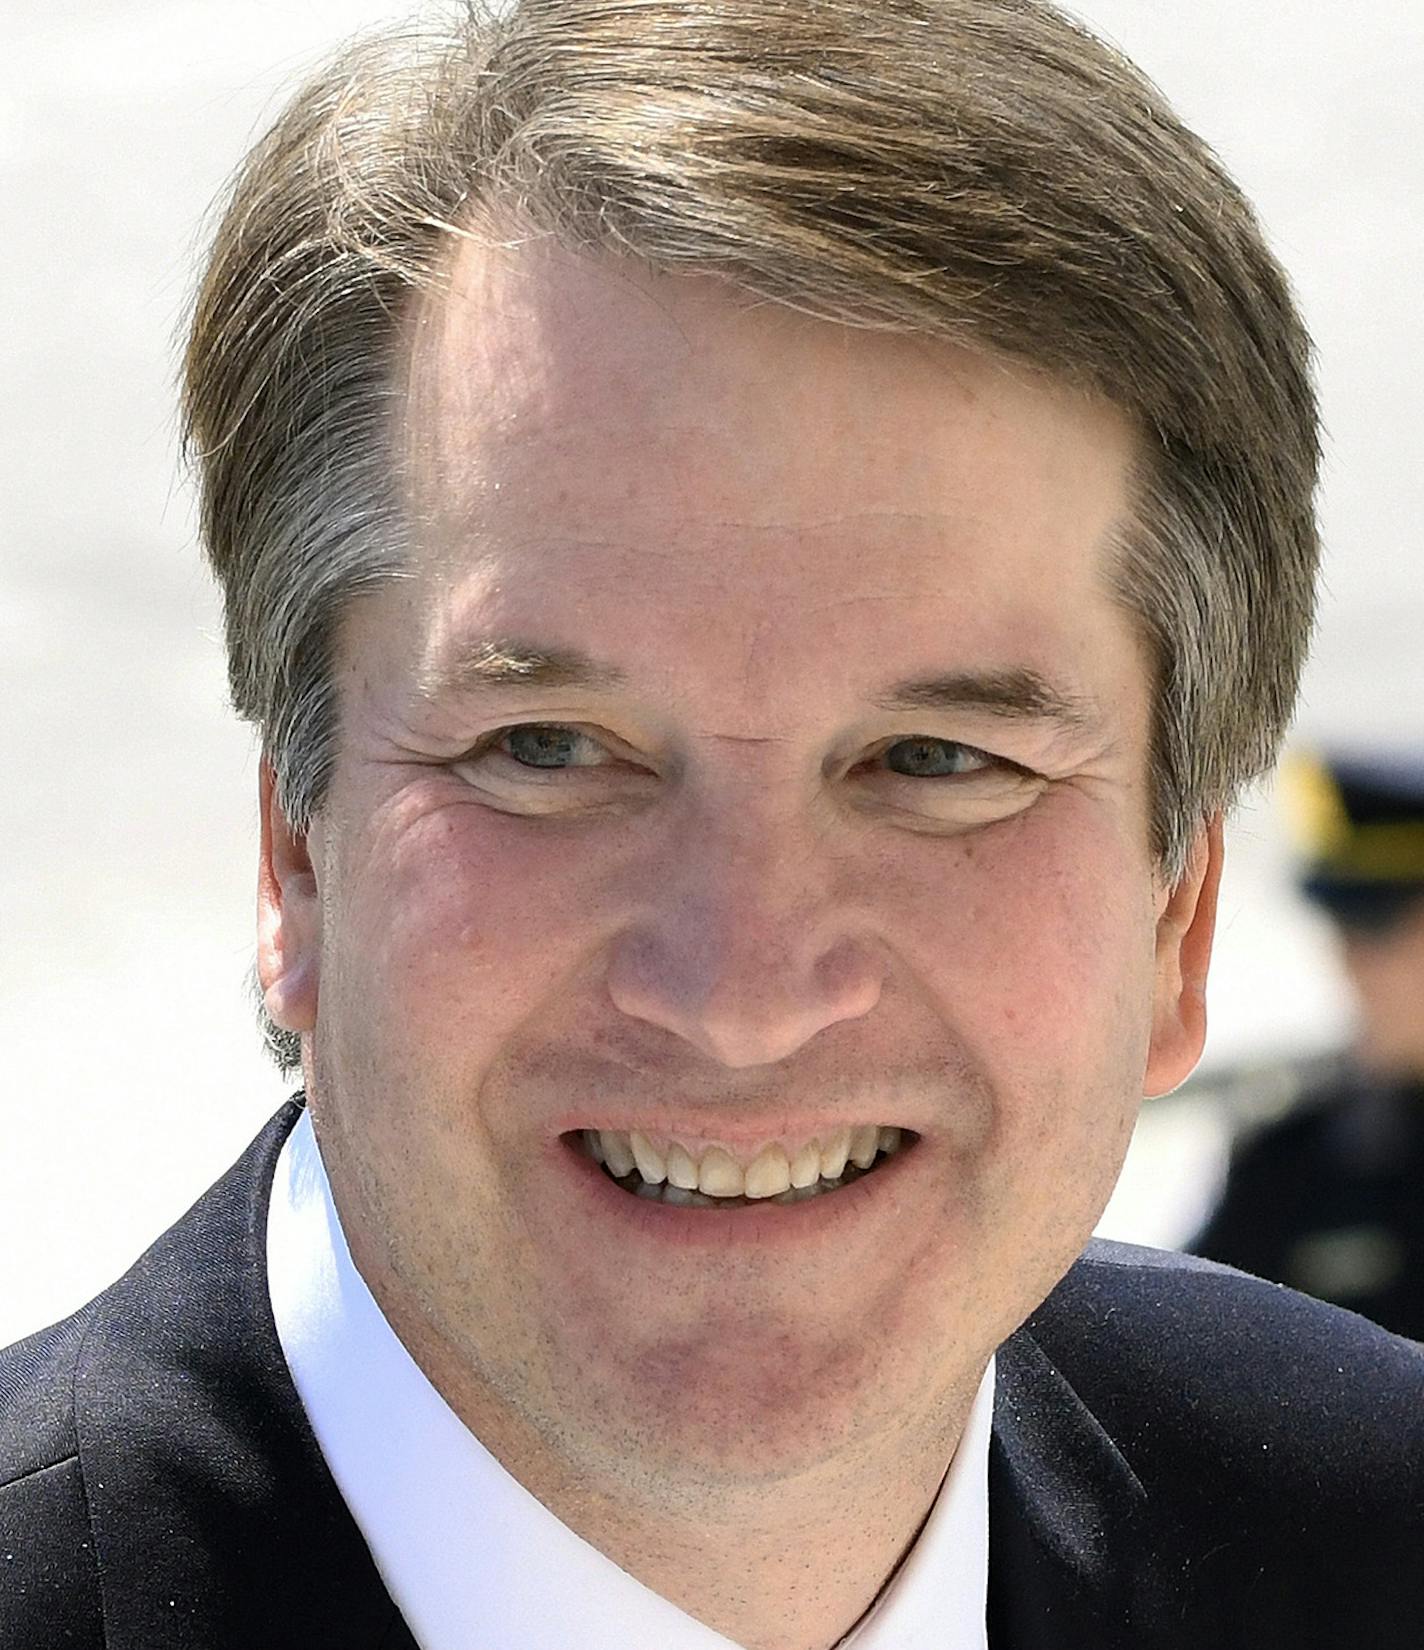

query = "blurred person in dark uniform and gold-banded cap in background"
(1190, 749), (1424, 1340)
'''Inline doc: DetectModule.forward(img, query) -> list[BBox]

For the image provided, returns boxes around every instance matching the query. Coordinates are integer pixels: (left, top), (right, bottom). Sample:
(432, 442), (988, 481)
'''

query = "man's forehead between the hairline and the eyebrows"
(392, 227), (1135, 709)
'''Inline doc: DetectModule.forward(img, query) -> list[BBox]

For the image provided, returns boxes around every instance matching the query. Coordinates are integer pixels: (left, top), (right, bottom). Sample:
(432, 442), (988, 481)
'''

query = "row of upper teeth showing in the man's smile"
(584, 1124), (901, 1198)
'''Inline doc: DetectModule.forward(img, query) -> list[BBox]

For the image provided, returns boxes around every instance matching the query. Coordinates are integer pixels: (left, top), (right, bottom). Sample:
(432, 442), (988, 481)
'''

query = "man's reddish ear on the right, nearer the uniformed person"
(1142, 813), (1223, 1099)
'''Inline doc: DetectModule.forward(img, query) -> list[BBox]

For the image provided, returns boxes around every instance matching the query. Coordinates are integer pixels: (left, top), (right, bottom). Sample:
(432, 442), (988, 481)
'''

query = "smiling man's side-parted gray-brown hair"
(185, 0), (1318, 1056)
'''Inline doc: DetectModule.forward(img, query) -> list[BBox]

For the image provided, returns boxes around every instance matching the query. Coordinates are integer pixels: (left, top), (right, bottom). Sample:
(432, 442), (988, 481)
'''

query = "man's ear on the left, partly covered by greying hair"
(257, 759), (322, 1031)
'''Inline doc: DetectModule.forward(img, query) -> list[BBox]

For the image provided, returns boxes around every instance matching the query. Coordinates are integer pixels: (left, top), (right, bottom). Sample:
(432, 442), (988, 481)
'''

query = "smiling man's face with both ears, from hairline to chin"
(264, 244), (1211, 1488)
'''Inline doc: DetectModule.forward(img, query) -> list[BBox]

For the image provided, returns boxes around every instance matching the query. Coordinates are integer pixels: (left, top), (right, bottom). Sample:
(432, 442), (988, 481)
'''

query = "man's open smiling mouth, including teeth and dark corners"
(573, 1124), (917, 1209)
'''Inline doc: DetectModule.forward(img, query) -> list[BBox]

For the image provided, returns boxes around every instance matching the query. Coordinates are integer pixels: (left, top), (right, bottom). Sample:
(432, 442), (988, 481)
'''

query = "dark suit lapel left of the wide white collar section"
(76, 1104), (416, 1650)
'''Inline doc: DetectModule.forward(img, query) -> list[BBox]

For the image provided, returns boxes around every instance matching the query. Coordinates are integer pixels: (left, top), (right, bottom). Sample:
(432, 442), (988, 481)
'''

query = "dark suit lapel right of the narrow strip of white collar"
(988, 1328), (1152, 1650)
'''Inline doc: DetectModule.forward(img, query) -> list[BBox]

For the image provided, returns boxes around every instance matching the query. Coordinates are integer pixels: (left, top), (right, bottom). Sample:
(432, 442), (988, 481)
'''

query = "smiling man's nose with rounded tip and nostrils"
(607, 822), (886, 1069)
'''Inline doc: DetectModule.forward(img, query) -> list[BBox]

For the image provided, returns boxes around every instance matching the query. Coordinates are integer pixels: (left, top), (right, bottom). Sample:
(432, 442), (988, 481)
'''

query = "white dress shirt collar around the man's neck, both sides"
(267, 1112), (993, 1650)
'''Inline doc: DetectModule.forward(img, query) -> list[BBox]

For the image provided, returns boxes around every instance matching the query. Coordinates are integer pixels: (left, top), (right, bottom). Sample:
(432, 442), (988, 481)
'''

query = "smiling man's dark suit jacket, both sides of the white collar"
(0, 1106), (1424, 1650)
